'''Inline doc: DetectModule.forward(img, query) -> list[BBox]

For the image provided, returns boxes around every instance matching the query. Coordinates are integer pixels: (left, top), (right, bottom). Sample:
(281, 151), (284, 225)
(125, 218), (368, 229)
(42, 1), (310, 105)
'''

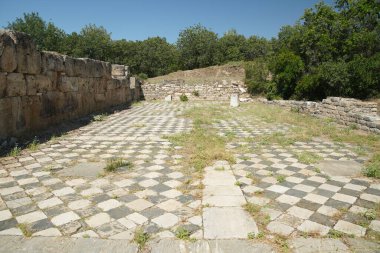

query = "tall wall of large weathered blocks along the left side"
(0, 30), (140, 139)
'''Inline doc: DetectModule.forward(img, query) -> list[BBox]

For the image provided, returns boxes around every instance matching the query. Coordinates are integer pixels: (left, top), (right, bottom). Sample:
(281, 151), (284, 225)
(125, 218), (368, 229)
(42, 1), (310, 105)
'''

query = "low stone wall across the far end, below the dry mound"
(141, 80), (246, 100)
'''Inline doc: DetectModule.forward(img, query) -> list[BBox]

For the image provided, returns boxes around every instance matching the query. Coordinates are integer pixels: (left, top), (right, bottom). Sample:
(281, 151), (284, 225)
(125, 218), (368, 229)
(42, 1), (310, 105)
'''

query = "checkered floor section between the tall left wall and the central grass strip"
(0, 103), (202, 239)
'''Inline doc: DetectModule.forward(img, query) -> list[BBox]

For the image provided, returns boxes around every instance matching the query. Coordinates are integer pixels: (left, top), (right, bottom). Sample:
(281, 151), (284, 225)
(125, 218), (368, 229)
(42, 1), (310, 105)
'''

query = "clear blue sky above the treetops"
(0, 0), (333, 42)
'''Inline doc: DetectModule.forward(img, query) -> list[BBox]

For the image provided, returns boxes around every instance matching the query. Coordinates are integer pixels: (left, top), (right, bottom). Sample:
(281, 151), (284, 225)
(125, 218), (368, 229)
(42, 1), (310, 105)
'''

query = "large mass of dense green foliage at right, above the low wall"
(273, 0), (380, 100)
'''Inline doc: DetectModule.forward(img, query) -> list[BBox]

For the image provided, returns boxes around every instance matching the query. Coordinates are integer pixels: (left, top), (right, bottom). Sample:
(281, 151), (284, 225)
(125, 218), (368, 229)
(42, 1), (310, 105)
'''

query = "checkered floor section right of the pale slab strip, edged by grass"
(229, 140), (380, 237)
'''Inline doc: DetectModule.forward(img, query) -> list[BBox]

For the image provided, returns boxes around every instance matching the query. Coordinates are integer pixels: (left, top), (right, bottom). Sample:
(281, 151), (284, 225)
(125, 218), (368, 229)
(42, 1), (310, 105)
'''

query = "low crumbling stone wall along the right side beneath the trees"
(259, 97), (380, 134)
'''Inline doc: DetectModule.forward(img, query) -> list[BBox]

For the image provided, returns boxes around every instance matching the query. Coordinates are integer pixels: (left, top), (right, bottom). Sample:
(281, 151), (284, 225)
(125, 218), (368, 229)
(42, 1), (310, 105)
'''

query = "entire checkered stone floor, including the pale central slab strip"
(0, 100), (380, 252)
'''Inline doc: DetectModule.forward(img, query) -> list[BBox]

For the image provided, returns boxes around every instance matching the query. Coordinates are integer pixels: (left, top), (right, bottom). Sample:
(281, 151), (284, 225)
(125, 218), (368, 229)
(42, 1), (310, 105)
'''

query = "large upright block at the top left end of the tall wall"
(0, 30), (17, 72)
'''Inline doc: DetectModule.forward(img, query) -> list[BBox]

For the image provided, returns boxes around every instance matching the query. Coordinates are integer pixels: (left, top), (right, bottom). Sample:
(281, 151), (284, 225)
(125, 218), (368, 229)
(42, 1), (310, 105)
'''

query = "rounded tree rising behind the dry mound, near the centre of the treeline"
(177, 24), (218, 69)
